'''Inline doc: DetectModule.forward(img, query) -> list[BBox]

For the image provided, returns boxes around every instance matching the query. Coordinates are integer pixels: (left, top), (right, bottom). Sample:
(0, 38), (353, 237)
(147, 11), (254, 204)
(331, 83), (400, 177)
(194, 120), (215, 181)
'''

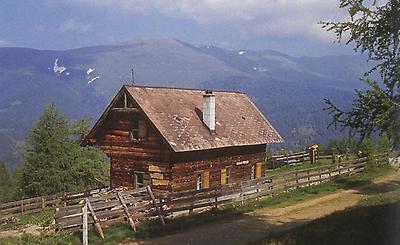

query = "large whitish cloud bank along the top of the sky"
(65, 0), (346, 40)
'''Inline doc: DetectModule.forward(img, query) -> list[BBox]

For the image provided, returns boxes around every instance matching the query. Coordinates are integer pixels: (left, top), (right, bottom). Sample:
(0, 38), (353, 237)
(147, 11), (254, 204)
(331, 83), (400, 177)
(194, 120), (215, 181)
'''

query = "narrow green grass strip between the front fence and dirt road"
(89, 162), (393, 244)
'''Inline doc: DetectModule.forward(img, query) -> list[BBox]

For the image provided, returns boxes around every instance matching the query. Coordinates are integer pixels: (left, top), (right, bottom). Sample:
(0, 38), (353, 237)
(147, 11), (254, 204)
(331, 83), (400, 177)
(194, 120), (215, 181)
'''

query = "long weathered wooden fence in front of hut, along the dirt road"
(56, 158), (367, 235)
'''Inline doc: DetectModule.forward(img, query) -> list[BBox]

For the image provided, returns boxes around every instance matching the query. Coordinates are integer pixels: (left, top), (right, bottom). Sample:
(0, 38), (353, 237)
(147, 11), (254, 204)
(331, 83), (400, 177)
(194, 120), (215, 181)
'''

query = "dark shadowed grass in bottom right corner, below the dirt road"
(254, 201), (400, 245)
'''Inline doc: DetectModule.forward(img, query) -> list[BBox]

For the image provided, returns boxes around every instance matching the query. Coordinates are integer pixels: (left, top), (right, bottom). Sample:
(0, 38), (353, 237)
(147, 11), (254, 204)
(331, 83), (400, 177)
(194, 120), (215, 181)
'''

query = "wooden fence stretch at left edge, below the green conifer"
(0, 189), (106, 218)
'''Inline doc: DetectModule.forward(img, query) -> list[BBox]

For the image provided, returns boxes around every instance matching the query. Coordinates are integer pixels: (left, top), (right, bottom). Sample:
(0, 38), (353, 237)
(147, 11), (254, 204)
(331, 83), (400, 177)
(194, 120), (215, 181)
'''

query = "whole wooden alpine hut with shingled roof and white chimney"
(84, 85), (283, 192)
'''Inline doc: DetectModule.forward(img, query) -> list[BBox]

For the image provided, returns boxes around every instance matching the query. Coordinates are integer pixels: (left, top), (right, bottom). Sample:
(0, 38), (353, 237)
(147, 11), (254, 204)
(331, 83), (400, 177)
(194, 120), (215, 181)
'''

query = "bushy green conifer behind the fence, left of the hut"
(20, 104), (109, 196)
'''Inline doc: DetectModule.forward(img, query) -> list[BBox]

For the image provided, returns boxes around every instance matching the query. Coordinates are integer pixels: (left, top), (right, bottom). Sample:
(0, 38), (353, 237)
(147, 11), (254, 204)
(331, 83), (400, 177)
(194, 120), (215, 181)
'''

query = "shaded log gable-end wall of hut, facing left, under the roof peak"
(96, 102), (172, 191)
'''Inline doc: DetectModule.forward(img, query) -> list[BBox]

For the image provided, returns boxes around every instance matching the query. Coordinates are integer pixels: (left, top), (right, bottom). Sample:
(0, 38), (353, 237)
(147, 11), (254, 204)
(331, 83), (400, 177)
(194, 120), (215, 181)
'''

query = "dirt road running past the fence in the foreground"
(125, 172), (400, 244)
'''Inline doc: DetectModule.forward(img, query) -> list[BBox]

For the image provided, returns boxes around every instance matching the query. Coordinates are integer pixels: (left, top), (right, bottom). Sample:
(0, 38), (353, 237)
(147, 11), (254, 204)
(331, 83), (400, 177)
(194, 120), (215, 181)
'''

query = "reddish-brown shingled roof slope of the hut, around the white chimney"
(86, 85), (283, 152)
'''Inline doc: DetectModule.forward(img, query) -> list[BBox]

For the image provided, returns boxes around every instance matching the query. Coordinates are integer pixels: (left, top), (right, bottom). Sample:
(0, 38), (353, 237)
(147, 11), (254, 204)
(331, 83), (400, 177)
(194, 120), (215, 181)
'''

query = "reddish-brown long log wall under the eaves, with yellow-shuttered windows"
(171, 145), (265, 192)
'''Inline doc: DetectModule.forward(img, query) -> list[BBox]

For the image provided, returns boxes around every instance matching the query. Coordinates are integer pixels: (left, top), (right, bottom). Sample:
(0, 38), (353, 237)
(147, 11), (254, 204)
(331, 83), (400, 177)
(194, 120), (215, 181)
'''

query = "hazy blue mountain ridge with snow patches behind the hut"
(0, 38), (369, 169)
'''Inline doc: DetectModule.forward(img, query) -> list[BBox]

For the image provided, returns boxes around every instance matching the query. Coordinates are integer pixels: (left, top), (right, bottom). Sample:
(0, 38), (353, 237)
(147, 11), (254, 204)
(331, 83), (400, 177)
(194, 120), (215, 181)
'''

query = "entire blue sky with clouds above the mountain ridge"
(0, 0), (352, 56)
